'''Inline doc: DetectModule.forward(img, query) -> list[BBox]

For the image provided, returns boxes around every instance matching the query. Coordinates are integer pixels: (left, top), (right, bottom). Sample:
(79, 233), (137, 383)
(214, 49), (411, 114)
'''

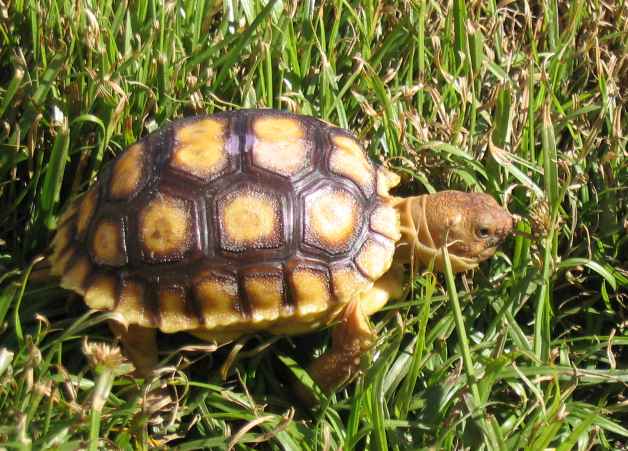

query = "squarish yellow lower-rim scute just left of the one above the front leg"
(290, 267), (331, 317)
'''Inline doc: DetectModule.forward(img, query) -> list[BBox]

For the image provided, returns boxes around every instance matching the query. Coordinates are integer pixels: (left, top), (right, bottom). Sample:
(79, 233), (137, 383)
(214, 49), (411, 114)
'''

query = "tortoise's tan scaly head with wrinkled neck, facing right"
(409, 191), (513, 272)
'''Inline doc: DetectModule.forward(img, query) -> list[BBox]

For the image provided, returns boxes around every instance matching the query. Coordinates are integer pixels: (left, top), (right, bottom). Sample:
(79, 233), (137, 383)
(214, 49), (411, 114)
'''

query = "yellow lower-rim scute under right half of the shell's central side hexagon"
(244, 273), (284, 322)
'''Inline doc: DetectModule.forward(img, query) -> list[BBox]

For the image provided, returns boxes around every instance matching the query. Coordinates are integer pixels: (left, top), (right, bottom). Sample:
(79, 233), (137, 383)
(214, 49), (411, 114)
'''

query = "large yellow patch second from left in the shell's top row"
(169, 119), (229, 182)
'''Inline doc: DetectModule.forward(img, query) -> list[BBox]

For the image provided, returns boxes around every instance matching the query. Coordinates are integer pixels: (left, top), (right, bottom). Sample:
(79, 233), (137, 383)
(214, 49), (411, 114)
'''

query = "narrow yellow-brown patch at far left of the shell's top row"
(109, 143), (144, 200)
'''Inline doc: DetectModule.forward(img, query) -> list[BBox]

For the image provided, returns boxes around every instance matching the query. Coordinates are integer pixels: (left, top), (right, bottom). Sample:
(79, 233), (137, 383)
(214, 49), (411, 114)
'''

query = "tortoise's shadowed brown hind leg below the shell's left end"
(109, 321), (159, 377)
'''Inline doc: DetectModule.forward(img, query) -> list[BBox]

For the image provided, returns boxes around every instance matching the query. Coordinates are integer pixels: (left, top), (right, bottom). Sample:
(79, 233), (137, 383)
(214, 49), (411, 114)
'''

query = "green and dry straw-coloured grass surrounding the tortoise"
(0, 0), (628, 451)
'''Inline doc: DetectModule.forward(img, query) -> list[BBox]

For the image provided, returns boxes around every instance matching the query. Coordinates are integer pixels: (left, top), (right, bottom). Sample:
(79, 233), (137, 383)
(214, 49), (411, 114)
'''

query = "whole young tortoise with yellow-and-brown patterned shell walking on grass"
(51, 110), (513, 391)
